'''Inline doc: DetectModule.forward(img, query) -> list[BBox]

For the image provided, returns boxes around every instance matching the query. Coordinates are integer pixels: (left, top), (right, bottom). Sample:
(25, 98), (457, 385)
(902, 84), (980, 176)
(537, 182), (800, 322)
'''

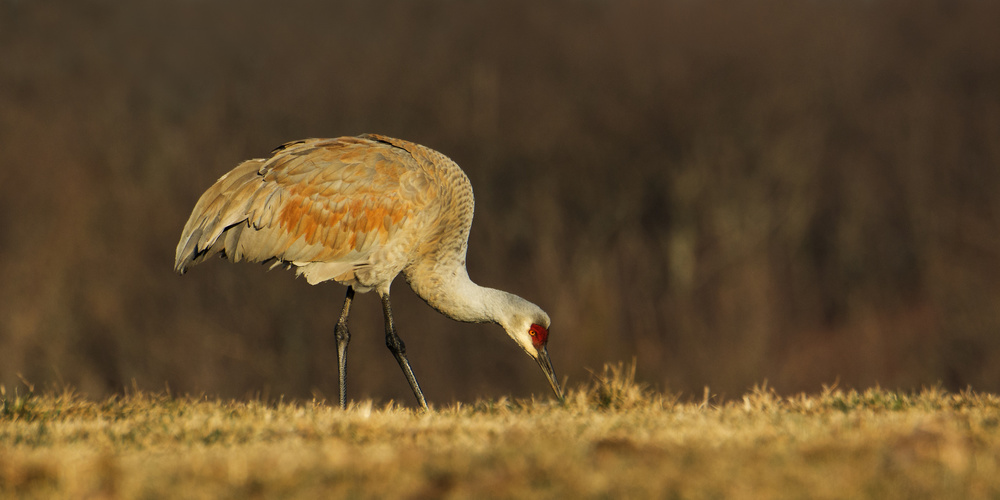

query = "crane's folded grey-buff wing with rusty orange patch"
(175, 137), (434, 283)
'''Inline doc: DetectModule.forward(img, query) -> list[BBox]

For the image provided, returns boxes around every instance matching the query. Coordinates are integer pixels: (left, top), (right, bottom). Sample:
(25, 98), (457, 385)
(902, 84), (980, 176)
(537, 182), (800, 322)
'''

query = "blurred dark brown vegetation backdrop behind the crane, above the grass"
(0, 0), (1000, 404)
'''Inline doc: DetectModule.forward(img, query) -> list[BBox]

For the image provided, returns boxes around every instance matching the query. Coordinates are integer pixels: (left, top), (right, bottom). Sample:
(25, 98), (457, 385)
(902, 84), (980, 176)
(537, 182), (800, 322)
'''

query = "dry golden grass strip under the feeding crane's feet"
(0, 365), (1000, 499)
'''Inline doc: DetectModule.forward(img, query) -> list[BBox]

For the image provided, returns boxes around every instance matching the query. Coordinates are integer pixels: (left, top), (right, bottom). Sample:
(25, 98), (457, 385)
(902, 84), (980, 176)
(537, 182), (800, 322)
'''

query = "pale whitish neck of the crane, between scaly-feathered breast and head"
(405, 264), (524, 326)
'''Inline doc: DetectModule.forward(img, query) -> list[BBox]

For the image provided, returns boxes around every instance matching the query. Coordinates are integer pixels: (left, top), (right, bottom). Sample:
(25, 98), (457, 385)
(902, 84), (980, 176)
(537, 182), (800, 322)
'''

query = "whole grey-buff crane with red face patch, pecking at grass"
(174, 134), (563, 409)
